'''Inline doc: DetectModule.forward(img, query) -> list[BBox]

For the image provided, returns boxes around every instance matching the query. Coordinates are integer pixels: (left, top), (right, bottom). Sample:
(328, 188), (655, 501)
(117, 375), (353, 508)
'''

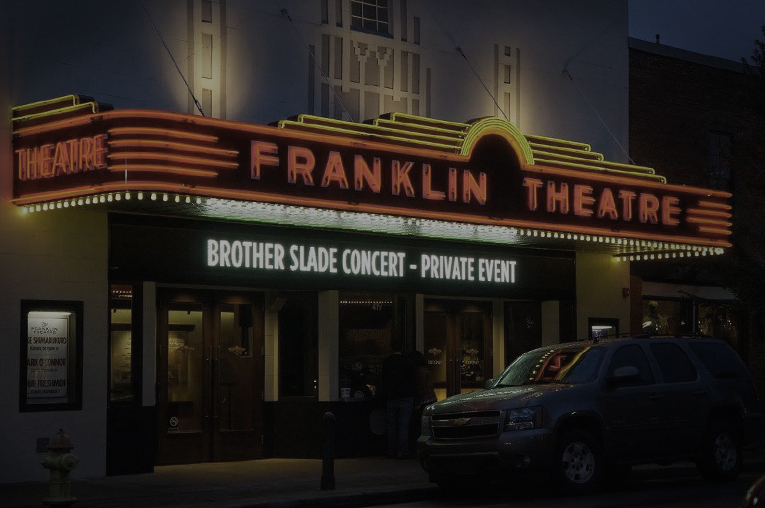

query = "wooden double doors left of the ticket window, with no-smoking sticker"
(157, 290), (263, 464)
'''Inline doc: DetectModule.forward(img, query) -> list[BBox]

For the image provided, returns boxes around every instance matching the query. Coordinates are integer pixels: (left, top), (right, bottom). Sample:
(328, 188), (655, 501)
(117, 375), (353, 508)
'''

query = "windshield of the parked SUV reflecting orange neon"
(494, 345), (605, 388)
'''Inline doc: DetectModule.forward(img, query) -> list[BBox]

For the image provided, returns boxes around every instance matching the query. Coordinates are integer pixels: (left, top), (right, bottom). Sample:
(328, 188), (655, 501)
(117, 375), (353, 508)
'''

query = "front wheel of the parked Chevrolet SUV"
(555, 429), (603, 494)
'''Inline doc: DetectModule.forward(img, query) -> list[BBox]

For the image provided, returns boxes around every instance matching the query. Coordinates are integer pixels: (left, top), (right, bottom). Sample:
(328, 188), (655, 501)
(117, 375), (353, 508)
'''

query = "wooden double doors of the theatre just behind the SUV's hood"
(423, 299), (492, 400)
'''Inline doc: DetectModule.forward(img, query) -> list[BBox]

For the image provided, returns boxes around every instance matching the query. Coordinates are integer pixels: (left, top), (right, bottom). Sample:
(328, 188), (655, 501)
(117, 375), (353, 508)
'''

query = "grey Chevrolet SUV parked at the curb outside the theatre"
(418, 337), (763, 493)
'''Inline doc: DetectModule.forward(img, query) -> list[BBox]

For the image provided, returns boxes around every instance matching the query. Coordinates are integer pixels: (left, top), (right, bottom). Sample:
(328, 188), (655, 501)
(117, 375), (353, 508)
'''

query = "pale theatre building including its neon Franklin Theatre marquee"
(0, 0), (731, 482)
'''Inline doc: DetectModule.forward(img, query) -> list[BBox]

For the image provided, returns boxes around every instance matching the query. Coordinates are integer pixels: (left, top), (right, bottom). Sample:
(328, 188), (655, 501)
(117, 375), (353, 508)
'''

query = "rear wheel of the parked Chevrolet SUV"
(698, 420), (742, 480)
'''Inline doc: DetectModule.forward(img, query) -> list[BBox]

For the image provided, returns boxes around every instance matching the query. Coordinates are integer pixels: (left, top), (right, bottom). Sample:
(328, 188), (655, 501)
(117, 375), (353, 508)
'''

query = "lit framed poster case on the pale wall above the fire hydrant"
(19, 300), (83, 412)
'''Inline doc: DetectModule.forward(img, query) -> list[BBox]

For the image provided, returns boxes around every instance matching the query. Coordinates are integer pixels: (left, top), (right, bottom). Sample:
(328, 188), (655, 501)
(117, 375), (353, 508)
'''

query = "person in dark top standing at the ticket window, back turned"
(382, 340), (414, 459)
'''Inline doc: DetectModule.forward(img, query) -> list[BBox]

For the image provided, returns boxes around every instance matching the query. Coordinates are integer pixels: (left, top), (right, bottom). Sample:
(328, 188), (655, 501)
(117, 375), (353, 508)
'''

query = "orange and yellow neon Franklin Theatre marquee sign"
(13, 96), (732, 252)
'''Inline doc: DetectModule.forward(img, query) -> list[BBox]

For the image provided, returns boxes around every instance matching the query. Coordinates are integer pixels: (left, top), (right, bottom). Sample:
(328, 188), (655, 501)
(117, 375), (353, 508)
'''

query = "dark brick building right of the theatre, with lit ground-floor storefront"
(629, 39), (765, 395)
